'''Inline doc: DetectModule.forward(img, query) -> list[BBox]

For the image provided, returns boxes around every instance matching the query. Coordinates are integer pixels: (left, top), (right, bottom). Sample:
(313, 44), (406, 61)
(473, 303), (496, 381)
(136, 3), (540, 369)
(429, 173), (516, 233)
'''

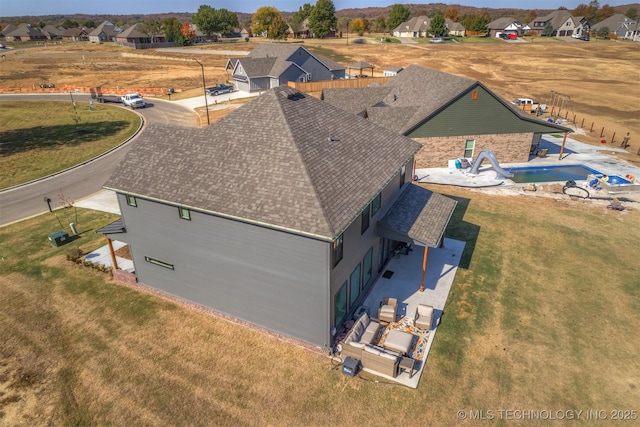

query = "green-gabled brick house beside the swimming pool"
(321, 65), (571, 168)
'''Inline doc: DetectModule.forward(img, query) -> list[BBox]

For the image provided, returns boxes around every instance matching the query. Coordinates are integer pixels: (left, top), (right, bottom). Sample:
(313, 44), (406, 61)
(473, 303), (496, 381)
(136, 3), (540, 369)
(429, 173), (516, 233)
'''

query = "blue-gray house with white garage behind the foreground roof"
(225, 43), (346, 92)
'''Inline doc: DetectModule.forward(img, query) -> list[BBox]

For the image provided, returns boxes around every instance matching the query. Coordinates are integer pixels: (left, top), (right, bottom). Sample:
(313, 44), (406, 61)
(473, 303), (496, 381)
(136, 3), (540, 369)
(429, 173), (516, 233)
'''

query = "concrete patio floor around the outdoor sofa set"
(348, 239), (465, 388)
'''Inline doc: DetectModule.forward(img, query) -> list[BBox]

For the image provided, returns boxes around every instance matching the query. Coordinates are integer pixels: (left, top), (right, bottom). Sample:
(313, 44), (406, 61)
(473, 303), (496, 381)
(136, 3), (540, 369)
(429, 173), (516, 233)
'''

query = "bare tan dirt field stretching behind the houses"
(0, 38), (640, 164)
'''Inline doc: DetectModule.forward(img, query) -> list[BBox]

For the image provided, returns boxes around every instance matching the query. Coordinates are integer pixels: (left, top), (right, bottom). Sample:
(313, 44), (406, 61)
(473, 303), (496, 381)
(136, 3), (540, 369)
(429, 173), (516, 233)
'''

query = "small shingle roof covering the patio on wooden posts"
(378, 184), (457, 247)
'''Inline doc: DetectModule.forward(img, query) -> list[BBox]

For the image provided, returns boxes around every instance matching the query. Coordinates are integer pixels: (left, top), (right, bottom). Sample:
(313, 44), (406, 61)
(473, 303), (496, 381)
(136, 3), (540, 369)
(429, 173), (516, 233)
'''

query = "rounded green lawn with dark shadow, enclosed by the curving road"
(0, 100), (141, 189)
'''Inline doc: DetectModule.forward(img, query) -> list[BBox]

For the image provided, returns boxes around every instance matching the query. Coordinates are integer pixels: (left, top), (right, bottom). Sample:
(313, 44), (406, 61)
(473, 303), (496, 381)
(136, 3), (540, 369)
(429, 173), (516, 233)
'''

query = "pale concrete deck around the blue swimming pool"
(415, 135), (640, 193)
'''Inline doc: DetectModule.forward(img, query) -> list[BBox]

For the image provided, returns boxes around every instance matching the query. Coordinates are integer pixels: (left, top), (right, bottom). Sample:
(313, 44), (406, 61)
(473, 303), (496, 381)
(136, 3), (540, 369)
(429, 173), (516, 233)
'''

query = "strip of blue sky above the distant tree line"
(0, 0), (635, 19)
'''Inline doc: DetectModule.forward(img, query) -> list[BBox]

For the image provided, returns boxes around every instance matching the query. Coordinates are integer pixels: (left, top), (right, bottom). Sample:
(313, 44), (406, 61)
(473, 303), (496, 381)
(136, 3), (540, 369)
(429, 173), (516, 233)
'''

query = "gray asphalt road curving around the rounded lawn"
(0, 94), (197, 226)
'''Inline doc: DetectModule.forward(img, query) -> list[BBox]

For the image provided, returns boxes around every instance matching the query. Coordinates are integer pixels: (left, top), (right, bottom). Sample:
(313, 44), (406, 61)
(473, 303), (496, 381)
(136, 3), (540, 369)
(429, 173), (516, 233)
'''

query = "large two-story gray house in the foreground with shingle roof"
(98, 86), (456, 350)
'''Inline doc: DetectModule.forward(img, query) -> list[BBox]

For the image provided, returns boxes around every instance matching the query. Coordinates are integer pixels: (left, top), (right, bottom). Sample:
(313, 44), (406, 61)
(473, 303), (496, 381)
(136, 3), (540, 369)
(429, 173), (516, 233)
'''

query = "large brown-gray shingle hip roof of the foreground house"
(105, 87), (420, 240)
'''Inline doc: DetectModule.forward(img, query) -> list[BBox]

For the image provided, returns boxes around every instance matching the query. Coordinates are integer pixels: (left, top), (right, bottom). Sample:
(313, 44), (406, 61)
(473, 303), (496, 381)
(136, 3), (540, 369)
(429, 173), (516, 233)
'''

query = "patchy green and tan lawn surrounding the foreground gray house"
(0, 187), (640, 426)
